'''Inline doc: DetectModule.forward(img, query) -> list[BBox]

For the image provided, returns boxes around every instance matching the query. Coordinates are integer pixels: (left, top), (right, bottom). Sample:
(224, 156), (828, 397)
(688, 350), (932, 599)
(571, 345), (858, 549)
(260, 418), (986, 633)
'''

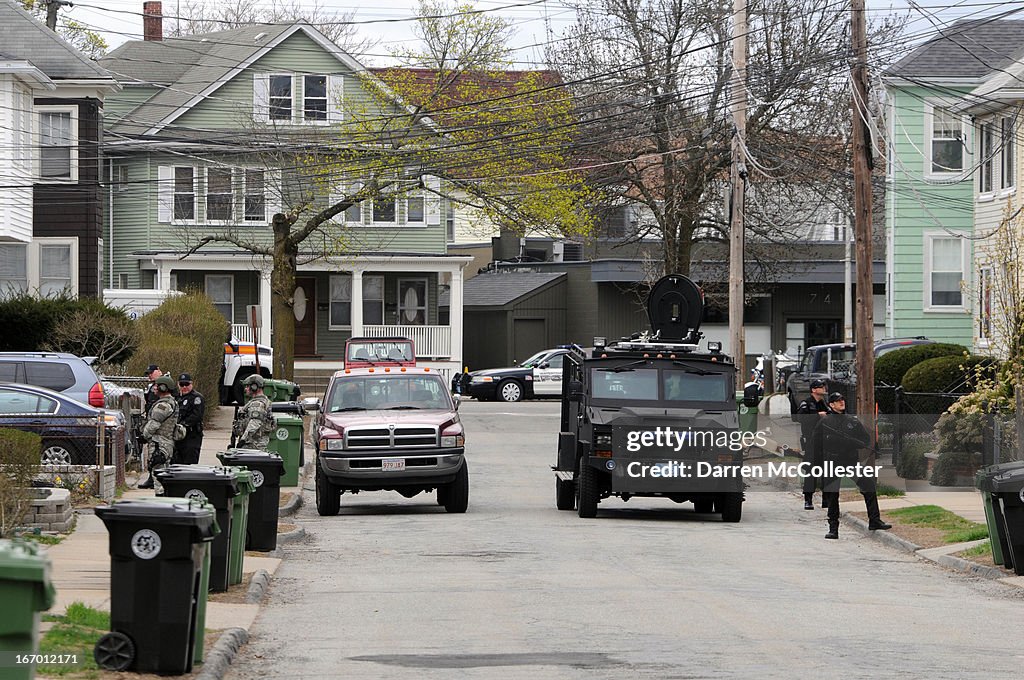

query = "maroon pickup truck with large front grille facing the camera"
(311, 365), (469, 516)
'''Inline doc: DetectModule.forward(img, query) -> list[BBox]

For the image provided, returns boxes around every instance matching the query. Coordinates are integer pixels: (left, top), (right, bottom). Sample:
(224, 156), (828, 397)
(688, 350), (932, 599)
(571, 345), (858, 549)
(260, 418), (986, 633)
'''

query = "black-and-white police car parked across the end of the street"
(462, 347), (573, 401)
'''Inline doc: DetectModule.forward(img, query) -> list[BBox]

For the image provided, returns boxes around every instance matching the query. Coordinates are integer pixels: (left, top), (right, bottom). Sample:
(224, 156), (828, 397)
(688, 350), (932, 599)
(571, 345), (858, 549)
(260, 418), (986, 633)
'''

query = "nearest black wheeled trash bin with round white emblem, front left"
(94, 499), (218, 675)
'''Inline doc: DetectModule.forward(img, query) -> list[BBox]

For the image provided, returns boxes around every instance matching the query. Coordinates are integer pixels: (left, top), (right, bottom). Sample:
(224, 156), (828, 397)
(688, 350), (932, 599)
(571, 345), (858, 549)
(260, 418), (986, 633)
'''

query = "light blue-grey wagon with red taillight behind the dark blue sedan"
(0, 352), (105, 409)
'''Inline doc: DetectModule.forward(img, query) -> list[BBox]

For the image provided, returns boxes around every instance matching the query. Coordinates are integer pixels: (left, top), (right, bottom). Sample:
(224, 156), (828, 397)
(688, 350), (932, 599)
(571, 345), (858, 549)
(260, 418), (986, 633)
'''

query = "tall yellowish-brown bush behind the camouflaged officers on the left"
(126, 291), (230, 419)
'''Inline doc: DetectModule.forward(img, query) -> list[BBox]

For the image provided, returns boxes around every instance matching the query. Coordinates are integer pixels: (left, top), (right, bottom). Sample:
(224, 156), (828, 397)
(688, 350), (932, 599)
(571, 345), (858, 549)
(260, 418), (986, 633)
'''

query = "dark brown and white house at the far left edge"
(0, 0), (119, 297)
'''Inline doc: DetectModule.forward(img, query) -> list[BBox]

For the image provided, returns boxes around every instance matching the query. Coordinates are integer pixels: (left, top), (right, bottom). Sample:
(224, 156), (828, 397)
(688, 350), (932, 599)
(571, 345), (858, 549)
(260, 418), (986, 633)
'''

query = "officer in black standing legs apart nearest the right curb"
(818, 392), (892, 539)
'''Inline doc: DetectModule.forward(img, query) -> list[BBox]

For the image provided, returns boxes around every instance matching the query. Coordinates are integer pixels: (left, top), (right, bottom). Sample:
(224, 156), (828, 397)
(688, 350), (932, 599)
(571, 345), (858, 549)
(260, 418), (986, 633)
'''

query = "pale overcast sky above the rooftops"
(49, 0), (1024, 68)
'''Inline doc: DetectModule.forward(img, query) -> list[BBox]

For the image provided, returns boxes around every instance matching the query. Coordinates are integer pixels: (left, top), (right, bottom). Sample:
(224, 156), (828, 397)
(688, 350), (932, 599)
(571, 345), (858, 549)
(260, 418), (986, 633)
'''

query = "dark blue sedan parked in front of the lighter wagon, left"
(0, 383), (125, 465)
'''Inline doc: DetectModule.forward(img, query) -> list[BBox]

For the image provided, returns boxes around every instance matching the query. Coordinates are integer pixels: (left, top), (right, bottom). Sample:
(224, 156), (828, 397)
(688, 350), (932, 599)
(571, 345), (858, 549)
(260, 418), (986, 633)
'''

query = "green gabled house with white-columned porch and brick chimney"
(101, 2), (470, 374)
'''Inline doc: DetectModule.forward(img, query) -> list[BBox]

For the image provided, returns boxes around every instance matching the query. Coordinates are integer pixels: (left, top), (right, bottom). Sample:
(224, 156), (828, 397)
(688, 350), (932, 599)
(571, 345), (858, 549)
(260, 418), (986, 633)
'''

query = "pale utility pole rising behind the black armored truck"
(729, 0), (746, 391)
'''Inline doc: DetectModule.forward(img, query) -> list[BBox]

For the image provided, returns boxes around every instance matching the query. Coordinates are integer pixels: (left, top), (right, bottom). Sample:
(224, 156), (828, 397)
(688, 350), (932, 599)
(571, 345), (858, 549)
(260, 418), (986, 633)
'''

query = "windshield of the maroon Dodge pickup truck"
(327, 375), (452, 413)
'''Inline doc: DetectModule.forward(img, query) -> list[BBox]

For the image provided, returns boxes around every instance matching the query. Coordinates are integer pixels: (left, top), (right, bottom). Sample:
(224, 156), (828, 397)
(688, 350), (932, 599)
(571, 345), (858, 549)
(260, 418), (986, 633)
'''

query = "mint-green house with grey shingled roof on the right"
(883, 18), (1024, 346)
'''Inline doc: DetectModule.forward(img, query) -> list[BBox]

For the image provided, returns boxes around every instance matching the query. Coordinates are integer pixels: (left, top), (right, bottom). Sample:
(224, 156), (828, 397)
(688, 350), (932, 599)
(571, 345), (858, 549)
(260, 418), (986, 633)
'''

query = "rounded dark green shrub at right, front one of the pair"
(902, 356), (997, 414)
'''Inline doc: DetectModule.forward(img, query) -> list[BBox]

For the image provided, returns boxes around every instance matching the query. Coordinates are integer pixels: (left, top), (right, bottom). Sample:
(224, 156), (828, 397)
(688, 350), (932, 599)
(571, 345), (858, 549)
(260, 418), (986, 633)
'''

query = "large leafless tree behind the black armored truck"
(548, 0), (900, 273)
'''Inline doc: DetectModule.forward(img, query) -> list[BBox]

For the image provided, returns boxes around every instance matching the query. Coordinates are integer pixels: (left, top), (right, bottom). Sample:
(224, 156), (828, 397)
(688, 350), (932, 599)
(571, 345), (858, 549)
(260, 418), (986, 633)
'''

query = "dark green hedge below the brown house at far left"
(0, 293), (127, 356)
